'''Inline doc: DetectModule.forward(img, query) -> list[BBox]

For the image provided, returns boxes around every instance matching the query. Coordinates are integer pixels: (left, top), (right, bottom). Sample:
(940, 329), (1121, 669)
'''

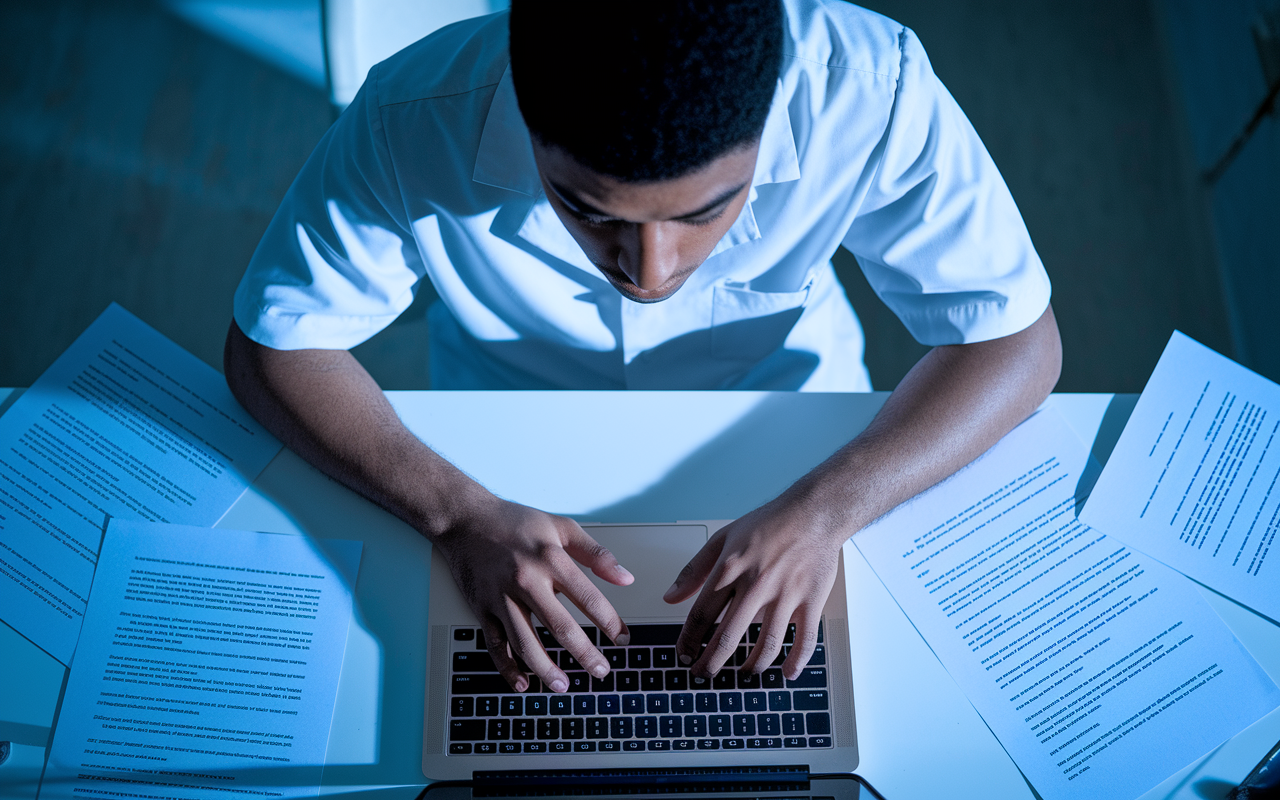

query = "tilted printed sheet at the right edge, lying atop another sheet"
(1080, 332), (1280, 621)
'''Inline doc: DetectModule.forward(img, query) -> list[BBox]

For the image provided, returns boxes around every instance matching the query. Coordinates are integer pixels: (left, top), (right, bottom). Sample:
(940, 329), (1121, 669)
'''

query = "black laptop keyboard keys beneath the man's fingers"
(449, 623), (832, 755)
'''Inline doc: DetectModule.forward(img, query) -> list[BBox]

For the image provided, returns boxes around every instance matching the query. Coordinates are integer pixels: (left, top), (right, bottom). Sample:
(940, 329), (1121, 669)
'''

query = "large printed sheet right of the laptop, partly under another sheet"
(854, 410), (1280, 800)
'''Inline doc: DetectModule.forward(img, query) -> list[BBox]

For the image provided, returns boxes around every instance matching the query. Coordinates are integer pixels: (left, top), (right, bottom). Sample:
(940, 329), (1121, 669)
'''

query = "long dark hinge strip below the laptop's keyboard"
(472, 764), (809, 797)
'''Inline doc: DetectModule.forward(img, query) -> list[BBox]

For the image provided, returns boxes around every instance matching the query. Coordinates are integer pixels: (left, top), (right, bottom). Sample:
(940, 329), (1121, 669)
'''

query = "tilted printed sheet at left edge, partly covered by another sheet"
(0, 303), (280, 664)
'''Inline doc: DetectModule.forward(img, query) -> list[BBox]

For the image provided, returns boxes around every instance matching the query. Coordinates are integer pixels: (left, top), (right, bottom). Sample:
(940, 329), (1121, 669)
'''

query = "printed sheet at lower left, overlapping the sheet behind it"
(40, 520), (361, 800)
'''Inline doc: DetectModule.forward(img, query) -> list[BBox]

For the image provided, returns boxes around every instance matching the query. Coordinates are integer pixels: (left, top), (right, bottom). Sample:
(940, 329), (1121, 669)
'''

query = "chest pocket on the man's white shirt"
(712, 278), (813, 361)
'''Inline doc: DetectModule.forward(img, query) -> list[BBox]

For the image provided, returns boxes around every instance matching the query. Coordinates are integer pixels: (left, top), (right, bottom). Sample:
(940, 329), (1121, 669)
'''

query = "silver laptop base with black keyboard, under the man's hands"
(422, 521), (858, 781)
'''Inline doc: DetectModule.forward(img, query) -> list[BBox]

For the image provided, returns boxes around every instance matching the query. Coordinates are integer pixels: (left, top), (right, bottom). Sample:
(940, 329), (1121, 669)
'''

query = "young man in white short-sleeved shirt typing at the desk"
(227, 0), (1060, 691)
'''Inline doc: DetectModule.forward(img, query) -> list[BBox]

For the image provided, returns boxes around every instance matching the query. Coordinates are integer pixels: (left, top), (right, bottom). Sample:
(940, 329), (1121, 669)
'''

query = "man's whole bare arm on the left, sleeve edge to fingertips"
(223, 321), (634, 691)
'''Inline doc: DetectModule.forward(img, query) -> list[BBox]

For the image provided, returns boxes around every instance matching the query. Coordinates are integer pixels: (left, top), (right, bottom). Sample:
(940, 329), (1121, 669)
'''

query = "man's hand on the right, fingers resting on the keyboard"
(663, 495), (849, 678)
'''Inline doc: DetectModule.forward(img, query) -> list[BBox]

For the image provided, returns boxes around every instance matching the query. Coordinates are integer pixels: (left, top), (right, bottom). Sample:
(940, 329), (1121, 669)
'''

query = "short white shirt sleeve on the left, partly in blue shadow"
(234, 68), (425, 349)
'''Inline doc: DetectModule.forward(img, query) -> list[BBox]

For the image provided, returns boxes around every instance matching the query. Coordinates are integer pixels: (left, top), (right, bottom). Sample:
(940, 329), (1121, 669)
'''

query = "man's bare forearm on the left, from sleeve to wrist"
(223, 321), (492, 540)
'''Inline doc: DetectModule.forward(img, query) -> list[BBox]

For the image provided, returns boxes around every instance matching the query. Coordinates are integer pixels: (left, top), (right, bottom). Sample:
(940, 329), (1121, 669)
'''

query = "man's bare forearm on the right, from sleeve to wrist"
(783, 307), (1062, 539)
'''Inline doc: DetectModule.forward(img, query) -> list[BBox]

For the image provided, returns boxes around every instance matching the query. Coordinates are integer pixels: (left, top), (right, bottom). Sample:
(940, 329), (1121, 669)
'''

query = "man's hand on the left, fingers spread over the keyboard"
(435, 498), (635, 692)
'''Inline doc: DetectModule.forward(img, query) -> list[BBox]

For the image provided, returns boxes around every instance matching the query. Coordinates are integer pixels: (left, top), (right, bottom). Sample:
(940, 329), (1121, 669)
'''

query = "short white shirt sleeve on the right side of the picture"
(844, 29), (1050, 346)
